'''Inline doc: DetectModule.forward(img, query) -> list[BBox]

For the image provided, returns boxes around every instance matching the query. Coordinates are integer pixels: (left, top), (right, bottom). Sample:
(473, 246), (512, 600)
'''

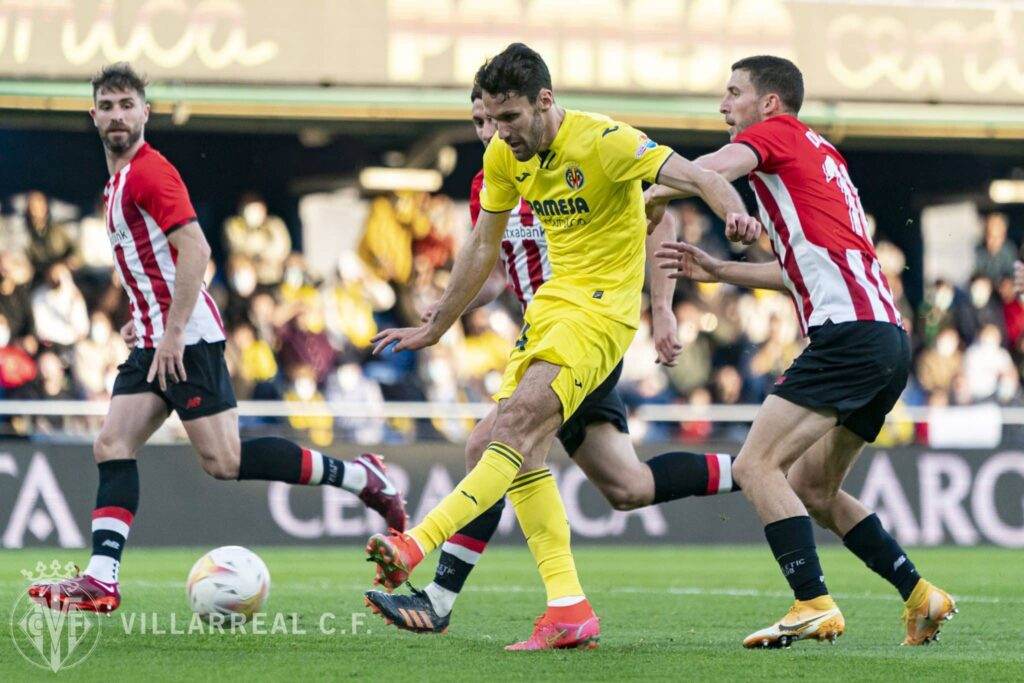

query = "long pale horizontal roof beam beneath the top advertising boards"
(0, 80), (1024, 148)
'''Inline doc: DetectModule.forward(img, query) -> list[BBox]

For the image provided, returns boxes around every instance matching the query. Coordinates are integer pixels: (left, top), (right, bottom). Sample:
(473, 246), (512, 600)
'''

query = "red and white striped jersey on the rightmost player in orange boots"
(734, 115), (902, 334)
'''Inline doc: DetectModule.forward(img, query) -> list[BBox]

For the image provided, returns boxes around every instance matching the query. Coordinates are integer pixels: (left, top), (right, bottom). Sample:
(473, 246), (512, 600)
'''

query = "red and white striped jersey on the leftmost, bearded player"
(103, 143), (224, 348)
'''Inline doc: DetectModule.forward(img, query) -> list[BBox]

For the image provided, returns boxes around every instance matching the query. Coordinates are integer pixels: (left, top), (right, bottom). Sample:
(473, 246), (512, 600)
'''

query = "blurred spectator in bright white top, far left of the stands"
(32, 261), (89, 355)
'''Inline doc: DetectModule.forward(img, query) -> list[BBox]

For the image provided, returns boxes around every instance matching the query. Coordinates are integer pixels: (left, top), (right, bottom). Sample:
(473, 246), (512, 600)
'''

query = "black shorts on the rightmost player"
(772, 321), (910, 442)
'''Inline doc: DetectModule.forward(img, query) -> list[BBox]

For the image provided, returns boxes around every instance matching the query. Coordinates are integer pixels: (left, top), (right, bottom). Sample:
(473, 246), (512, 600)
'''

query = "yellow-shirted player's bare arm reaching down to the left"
(371, 211), (509, 355)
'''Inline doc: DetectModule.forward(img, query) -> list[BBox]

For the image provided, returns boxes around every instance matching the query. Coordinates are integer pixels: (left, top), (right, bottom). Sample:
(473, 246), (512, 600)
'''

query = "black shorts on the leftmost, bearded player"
(114, 341), (238, 422)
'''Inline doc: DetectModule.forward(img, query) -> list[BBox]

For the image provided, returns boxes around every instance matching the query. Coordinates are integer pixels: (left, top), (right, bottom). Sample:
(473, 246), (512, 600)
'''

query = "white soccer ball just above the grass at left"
(185, 546), (270, 623)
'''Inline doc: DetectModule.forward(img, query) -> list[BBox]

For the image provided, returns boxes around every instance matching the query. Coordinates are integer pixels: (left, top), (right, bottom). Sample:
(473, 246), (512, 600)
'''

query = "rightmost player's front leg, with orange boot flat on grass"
(734, 395), (845, 647)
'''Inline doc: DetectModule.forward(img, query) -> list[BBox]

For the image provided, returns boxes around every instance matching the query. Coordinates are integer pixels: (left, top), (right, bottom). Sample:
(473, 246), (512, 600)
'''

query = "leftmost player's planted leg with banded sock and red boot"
(29, 393), (168, 613)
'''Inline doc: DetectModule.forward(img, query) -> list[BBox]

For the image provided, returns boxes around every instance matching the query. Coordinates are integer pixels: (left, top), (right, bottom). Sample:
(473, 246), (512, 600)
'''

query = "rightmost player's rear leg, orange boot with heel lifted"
(788, 426), (956, 645)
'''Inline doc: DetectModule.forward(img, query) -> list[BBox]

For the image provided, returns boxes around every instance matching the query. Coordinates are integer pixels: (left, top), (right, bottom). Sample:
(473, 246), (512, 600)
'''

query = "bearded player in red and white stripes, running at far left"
(29, 62), (406, 612)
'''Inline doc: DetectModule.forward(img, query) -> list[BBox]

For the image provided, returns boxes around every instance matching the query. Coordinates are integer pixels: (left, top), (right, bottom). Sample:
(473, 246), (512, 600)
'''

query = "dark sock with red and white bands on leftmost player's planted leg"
(85, 459), (138, 584)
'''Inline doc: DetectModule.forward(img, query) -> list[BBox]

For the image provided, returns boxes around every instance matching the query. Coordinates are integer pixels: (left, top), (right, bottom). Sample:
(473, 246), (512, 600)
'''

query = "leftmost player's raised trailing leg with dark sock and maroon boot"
(182, 409), (407, 530)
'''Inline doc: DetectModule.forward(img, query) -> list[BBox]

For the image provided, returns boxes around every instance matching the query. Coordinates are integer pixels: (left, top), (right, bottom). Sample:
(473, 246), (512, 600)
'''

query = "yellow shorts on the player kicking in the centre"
(494, 297), (636, 422)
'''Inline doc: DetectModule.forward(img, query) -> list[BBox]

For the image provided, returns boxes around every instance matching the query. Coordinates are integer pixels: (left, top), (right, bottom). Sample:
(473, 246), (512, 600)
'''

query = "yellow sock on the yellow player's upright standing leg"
(508, 468), (584, 603)
